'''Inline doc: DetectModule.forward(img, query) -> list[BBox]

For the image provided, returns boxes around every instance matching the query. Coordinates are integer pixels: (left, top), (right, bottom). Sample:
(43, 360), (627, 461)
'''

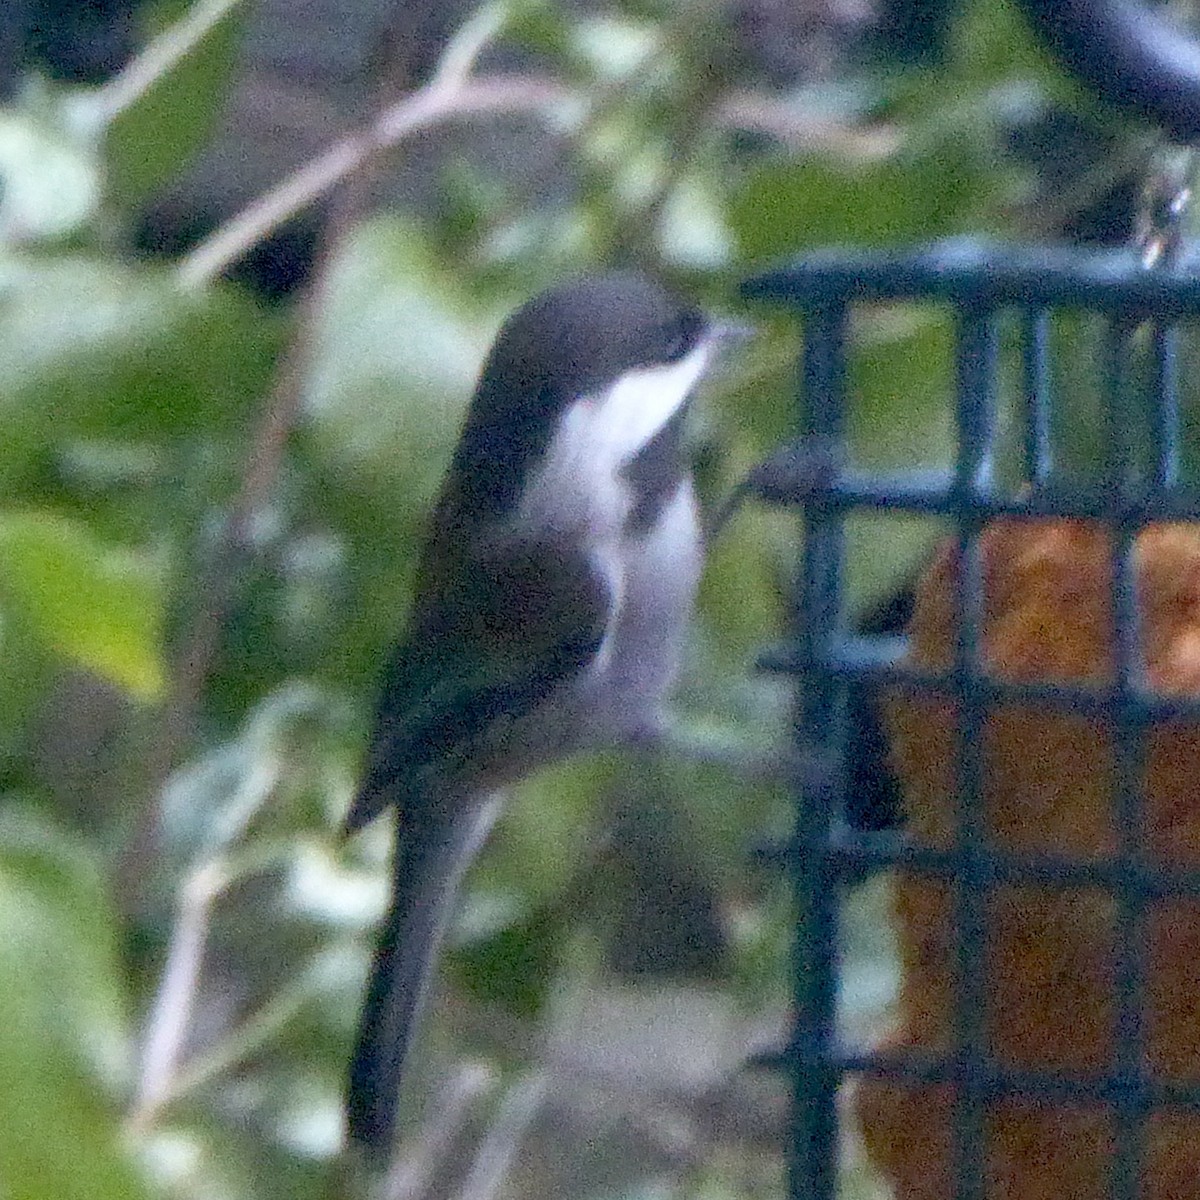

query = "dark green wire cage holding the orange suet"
(745, 241), (1200, 1200)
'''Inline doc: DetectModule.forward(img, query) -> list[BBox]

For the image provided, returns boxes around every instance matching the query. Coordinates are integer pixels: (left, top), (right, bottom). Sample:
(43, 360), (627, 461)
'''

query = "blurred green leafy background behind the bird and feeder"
(0, 0), (1150, 1200)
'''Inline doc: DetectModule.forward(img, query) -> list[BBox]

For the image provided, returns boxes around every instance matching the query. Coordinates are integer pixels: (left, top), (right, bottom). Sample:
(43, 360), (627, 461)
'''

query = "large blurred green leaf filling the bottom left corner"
(0, 814), (145, 1200)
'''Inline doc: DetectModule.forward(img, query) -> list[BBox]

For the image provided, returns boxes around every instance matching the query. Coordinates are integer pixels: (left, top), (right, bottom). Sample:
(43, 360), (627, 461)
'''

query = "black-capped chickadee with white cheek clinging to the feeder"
(347, 274), (725, 1154)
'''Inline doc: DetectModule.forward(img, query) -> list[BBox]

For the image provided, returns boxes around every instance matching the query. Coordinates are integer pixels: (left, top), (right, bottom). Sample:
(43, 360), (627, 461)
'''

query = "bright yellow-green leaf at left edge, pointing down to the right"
(0, 512), (163, 698)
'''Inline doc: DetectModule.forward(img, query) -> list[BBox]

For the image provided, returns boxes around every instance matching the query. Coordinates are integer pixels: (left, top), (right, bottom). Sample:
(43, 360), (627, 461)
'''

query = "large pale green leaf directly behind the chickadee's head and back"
(298, 218), (512, 688)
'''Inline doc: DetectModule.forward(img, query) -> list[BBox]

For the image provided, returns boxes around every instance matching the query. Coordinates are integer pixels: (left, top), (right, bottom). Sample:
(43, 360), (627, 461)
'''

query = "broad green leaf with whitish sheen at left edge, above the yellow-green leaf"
(0, 256), (277, 468)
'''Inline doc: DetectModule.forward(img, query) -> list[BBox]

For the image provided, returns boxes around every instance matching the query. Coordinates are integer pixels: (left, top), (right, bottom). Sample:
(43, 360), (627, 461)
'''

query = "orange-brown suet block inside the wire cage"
(857, 520), (1200, 1200)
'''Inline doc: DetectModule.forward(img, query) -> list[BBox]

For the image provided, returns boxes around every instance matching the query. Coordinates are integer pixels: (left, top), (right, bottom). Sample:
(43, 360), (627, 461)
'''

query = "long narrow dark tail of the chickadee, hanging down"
(346, 797), (499, 1158)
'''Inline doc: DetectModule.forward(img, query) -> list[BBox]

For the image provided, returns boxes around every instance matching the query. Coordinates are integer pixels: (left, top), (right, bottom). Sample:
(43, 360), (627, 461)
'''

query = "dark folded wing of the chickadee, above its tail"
(346, 539), (613, 830)
